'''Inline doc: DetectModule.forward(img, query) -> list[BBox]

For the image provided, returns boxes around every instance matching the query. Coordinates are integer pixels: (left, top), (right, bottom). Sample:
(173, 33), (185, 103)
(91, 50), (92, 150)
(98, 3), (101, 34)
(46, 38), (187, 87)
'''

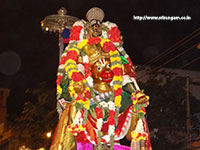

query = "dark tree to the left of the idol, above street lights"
(18, 82), (58, 148)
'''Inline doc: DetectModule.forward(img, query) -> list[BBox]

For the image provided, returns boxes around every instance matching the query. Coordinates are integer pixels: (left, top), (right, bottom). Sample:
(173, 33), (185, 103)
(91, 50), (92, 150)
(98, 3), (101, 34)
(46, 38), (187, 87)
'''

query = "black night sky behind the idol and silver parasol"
(0, 0), (200, 119)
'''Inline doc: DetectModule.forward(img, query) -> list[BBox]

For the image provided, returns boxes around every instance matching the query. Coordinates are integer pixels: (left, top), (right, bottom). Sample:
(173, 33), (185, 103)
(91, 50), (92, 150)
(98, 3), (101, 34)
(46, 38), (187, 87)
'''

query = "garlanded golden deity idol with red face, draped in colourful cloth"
(50, 7), (151, 150)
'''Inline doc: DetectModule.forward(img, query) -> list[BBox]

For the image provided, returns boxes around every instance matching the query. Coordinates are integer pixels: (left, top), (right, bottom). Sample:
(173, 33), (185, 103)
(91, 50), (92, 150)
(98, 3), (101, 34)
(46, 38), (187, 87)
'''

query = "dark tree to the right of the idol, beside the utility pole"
(139, 68), (190, 150)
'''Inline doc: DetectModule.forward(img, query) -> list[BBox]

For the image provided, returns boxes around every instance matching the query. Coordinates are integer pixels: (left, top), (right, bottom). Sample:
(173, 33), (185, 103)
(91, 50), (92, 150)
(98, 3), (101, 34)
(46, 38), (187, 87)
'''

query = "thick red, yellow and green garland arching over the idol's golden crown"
(57, 37), (122, 134)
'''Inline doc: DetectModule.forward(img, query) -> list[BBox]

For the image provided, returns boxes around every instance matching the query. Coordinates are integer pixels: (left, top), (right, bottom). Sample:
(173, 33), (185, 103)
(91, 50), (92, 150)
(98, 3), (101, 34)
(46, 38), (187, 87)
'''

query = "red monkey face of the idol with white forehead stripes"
(92, 58), (114, 83)
